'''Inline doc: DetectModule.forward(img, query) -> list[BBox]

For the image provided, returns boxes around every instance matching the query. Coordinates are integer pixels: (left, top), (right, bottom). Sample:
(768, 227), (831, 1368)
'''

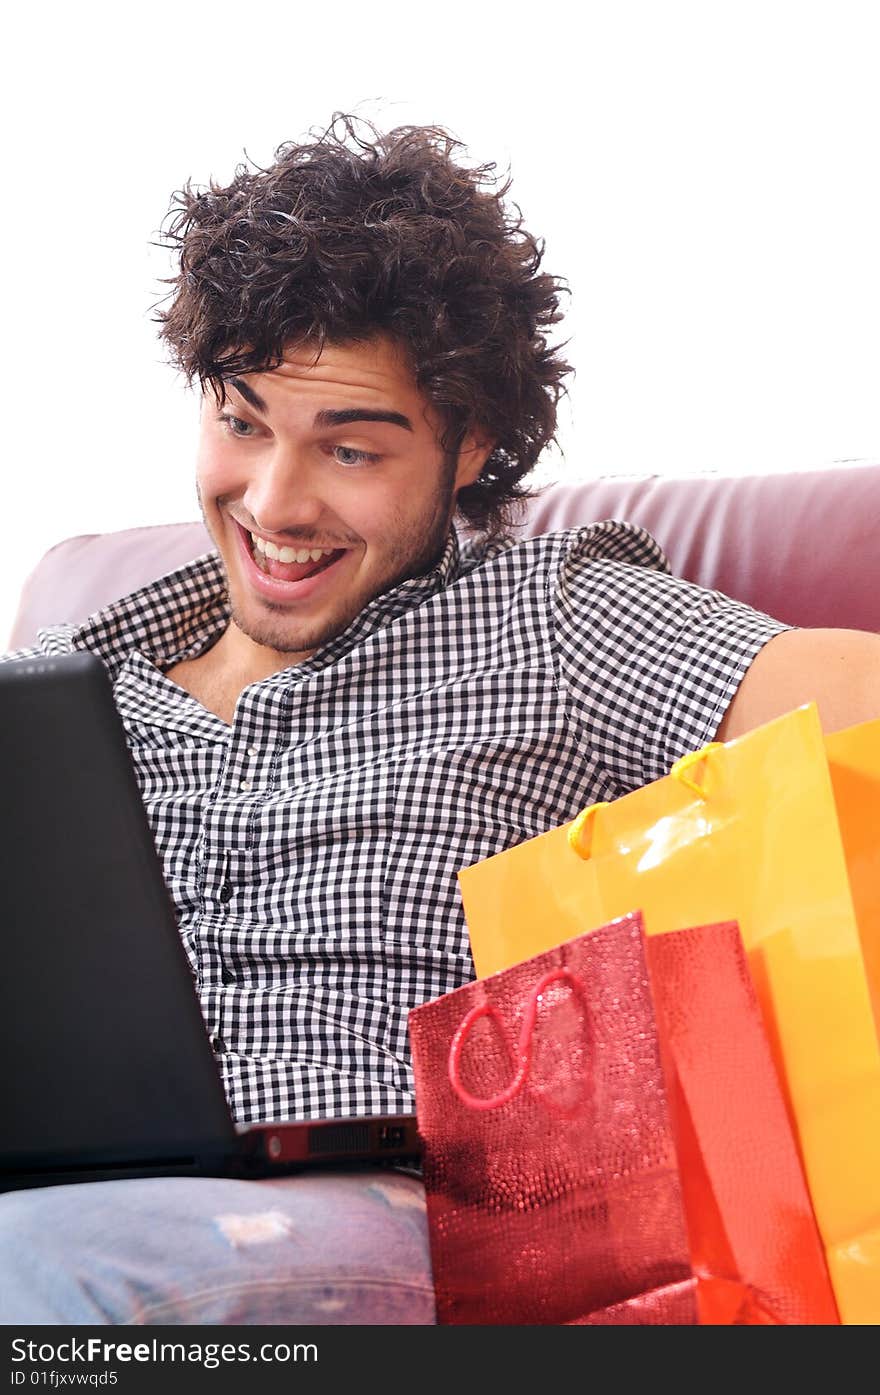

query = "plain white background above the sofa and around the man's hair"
(0, 0), (880, 646)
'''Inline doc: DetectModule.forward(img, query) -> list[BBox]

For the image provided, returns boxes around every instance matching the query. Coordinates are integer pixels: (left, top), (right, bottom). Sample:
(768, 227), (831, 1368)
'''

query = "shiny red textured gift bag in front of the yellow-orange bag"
(410, 914), (838, 1325)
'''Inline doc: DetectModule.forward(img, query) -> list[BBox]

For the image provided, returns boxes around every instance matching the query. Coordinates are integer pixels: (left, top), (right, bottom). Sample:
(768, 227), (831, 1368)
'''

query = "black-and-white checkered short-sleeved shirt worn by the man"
(7, 522), (787, 1123)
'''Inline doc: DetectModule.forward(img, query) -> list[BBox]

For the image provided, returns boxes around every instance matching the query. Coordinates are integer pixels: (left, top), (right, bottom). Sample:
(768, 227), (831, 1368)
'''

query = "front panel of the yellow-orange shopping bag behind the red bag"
(459, 703), (880, 1322)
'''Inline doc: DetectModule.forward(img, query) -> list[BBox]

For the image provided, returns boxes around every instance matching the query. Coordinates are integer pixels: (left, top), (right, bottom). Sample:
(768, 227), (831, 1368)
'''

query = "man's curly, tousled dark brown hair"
(156, 113), (570, 534)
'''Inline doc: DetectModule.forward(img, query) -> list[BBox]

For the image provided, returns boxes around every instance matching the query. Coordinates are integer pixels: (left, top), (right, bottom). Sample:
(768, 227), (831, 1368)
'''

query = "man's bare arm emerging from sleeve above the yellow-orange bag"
(715, 629), (880, 741)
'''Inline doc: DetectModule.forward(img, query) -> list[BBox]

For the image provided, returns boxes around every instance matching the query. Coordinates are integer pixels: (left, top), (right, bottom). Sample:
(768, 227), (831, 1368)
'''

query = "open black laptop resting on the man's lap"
(0, 653), (421, 1191)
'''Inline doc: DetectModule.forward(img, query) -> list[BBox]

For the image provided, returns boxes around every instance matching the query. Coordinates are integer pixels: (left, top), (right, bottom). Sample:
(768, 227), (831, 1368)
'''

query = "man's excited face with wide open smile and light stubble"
(198, 339), (491, 667)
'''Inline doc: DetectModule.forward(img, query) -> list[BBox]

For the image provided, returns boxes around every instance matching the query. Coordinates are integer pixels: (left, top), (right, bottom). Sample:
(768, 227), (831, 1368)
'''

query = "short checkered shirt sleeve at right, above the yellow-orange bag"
(551, 523), (794, 792)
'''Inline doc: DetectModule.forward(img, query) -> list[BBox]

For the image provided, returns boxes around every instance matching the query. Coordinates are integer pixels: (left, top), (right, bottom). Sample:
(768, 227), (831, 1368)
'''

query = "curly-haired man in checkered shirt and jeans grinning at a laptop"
(0, 121), (880, 1322)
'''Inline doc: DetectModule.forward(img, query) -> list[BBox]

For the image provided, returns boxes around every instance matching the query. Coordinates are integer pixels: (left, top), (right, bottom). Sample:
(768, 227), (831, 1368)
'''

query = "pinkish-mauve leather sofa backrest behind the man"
(10, 462), (880, 647)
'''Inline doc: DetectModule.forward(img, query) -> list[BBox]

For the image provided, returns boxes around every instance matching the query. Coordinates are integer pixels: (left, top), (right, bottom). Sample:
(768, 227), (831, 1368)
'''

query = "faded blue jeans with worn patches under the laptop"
(0, 1169), (435, 1327)
